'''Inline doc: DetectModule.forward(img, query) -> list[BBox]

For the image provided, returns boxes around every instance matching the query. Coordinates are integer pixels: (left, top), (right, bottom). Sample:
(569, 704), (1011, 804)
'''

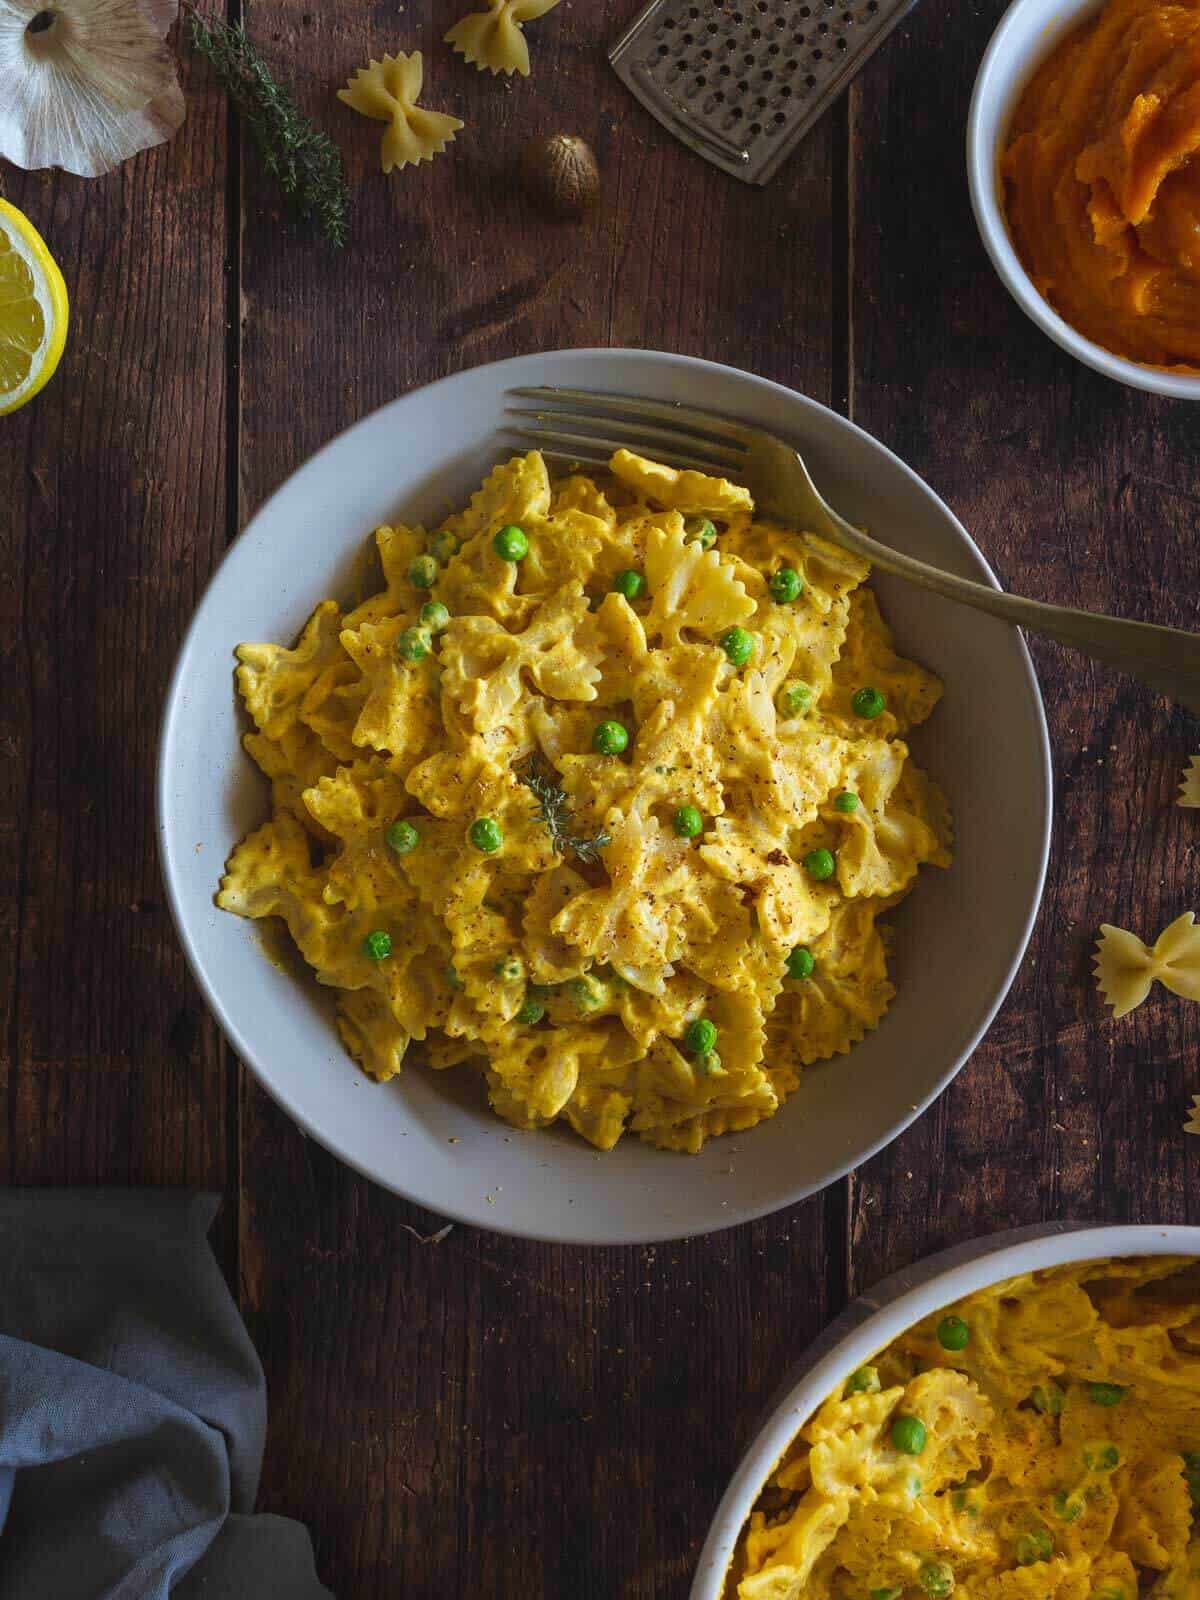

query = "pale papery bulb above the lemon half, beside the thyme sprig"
(0, 0), (186, 178)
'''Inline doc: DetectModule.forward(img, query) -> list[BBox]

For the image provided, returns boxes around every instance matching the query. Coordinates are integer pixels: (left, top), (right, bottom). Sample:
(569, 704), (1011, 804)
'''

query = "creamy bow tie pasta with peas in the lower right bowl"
(728, 1256), (1200, 1600)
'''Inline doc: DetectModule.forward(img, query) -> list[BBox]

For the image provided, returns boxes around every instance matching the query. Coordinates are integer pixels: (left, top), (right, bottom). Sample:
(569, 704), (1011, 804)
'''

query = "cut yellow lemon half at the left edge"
(0, 200), (70, 416)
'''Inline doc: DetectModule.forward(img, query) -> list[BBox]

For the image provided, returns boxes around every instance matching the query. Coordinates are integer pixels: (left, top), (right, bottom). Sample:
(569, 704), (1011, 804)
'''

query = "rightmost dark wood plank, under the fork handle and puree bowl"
(851, 0), (1200, 1288)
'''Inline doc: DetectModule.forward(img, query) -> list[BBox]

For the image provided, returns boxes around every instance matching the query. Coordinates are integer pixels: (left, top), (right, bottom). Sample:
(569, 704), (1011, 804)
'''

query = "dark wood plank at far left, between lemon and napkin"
(0, 46), (232, 1209)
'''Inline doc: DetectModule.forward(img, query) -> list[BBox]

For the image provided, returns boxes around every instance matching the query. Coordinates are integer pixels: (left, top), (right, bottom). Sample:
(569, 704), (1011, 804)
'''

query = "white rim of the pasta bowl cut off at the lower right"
(690, 1222), (1200, 1600)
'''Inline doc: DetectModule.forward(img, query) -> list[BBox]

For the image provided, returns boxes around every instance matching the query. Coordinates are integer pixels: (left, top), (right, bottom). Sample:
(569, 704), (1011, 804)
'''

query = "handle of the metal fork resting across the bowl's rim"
(827, 506), (1200, 715)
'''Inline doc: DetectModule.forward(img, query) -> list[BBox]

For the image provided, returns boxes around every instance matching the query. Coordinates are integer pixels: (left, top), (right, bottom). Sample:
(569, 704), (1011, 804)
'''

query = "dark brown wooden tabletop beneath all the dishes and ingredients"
(0, 0), (1200, 1600)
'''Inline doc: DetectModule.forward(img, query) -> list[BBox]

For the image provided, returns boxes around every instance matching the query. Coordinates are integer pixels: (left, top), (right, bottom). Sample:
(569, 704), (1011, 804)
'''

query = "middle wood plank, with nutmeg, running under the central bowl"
(242, 0), (845, 1600)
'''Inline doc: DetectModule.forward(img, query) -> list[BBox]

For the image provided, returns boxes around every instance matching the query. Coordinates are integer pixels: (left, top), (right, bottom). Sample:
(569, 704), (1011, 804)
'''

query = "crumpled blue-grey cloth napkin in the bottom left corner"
(0, 1189), (333, 1600)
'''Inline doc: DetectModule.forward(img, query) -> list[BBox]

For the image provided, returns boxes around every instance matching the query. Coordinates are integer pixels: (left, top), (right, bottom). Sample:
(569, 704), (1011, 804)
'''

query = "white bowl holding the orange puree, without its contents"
(966, 0), (1200, 400)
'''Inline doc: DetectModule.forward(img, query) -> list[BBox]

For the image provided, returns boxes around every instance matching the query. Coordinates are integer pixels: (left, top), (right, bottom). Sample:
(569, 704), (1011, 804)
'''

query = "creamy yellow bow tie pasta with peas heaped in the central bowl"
(218, 451), (950, 1150)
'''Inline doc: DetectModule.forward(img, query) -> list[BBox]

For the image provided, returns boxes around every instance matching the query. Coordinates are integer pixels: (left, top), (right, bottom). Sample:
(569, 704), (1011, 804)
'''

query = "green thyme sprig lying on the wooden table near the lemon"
(189, 11), (350, 248)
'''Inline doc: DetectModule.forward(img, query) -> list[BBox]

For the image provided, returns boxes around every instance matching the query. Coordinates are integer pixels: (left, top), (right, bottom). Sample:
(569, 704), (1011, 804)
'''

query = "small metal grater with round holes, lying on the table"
(608, 0), (915, 184)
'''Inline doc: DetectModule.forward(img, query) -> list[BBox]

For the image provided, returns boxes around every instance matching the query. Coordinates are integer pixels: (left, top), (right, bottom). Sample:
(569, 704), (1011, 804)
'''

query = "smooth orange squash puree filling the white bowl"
(1002, 0), (1200, 368)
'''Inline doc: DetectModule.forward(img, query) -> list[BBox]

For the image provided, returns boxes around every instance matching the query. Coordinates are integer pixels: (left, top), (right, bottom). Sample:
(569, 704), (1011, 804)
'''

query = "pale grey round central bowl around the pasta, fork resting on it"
(158, 350), (1050, 1243)
